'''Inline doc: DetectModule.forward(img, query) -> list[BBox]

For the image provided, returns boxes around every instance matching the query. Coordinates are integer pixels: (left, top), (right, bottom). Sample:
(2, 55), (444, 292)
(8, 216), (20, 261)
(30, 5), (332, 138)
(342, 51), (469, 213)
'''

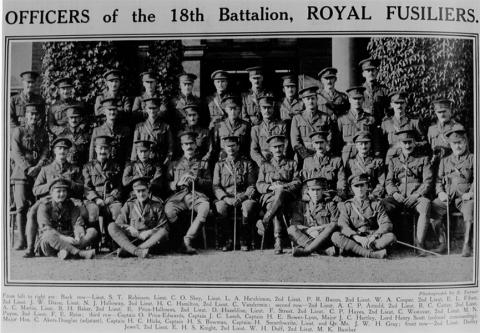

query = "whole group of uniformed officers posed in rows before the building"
(9, 58), (475, 259)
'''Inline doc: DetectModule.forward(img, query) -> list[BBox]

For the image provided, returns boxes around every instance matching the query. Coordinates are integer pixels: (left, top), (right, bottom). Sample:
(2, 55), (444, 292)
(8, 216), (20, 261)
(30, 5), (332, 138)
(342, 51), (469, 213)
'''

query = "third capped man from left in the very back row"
(95, 69), (132, 118)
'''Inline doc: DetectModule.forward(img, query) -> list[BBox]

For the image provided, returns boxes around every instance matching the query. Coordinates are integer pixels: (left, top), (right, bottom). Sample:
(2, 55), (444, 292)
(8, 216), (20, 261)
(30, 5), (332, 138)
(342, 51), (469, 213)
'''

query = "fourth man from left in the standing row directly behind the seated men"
(130, 98), (174, 168)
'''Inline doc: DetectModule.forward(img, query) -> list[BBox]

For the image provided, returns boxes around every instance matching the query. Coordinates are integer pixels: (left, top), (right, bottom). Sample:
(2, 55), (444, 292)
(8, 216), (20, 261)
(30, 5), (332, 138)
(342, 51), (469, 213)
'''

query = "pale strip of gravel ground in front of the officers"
(9, 245), (474, 284)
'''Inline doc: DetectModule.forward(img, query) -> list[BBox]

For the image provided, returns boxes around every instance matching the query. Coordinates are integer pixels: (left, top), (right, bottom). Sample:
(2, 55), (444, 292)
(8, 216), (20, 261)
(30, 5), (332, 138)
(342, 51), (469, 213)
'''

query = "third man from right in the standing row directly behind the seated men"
(338, 87), (381, 165)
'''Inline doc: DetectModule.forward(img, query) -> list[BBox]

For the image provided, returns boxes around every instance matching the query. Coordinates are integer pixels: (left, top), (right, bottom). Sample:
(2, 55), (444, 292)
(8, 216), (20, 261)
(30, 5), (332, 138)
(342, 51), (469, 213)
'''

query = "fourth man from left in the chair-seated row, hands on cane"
(165, 132), (212, 254)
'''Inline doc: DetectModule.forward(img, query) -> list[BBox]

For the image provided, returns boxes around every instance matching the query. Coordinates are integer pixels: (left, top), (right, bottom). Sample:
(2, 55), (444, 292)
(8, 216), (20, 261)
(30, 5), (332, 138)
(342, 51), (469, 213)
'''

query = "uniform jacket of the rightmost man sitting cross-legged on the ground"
(338, 198), (393, 237)
